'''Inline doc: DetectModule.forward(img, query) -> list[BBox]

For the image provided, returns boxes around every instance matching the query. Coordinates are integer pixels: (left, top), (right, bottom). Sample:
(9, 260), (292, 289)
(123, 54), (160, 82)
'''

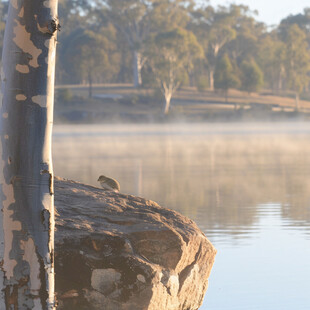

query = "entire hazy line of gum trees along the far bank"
(0, 0), (310, 112)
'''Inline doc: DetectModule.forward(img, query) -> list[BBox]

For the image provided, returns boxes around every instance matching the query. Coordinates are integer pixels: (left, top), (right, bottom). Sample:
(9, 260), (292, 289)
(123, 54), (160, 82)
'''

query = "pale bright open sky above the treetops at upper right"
(208, 0), (310, 25)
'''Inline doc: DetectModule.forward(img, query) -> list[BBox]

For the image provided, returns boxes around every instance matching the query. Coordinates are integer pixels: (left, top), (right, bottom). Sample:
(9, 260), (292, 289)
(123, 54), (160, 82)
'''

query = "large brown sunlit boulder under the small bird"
(55, 178), (216, 310)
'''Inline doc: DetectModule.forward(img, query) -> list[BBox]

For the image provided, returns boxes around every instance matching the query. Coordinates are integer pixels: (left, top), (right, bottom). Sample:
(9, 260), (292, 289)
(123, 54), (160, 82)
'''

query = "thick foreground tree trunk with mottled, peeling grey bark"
(0, 0), (59, 310)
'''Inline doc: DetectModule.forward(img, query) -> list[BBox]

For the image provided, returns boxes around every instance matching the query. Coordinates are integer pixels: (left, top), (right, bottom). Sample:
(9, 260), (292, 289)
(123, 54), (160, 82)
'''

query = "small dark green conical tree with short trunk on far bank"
(214, 55), (240, 102)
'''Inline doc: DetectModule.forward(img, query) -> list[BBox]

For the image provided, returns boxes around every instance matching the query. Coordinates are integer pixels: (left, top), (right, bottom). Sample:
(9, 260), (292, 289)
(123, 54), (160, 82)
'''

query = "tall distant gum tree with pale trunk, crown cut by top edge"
(97, 0), (192, 87)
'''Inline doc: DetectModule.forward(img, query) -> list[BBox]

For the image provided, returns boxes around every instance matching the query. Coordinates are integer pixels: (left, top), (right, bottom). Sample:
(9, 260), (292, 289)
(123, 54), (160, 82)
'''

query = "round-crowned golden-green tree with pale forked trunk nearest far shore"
(147, 28), (203, 114)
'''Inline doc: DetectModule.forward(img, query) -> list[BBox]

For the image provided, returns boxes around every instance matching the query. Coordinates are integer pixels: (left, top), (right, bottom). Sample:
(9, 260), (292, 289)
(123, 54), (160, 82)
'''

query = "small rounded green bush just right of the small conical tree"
(240, 59), (264, 94)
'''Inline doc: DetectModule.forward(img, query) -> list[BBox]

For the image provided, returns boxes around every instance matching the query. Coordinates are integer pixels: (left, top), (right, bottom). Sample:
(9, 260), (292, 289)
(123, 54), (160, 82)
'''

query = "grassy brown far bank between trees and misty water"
(55, 84), (310, 123)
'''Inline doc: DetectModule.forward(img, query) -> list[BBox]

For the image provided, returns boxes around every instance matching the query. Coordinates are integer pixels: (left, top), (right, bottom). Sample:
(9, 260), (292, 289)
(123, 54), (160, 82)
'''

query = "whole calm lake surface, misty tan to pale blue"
(53, 124), (310, 310)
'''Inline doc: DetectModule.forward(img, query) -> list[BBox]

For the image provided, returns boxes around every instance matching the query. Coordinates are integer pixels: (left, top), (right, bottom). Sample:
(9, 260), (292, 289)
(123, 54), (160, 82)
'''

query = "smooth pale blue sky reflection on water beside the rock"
(205, 203), (310, 310)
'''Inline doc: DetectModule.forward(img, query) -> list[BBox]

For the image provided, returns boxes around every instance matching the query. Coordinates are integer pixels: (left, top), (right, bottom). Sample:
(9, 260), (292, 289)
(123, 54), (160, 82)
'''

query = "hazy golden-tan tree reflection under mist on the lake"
(54, 121), (310, 242)
